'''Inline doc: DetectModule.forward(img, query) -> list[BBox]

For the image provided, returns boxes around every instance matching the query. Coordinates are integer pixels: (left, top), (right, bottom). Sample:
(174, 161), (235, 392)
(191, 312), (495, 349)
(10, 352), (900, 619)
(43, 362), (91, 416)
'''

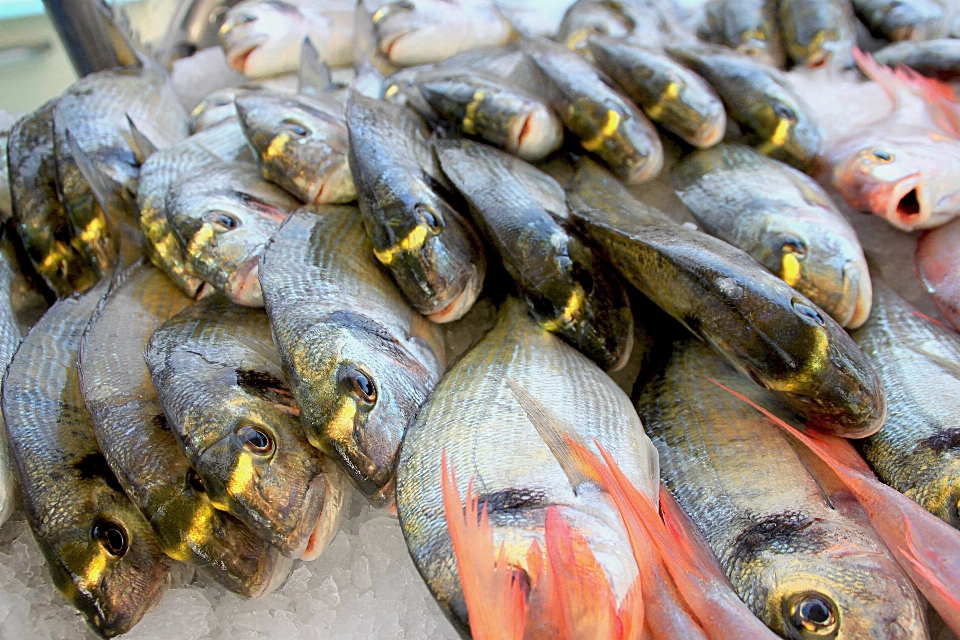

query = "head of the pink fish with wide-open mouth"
(823, 133), (960, 231)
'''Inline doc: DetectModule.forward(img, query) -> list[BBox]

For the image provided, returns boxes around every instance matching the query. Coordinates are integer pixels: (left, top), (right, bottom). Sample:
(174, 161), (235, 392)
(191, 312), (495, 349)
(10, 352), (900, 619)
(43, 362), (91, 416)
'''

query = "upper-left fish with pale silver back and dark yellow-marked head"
(53, 62), (188, 272)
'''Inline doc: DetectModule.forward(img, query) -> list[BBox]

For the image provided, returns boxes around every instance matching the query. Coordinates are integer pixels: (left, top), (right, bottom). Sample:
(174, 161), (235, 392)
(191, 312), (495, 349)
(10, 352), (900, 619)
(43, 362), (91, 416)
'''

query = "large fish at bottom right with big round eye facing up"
(637, 340), (929, 640)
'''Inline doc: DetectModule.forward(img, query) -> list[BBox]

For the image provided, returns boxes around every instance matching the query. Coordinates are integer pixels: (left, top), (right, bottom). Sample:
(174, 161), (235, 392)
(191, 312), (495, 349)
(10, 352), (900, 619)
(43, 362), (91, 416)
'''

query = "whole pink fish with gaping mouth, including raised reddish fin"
(816, 52), (960, 231)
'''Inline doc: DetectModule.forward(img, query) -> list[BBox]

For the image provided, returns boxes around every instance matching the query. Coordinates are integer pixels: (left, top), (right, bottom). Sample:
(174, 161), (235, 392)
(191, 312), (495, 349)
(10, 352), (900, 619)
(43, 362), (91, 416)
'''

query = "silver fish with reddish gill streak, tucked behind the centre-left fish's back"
(166, 162), (300, 307)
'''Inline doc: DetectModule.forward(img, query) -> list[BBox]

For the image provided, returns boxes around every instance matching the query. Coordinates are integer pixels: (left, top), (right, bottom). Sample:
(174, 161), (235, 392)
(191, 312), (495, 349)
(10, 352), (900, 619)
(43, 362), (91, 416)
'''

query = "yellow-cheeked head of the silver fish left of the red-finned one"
(290, 311), (439, 504)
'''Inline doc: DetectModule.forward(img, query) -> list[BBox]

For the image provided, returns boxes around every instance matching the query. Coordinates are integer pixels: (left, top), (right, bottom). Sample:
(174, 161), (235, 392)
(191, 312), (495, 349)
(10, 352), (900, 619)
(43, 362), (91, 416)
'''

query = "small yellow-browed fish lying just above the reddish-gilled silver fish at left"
(236, 91), (357, 204)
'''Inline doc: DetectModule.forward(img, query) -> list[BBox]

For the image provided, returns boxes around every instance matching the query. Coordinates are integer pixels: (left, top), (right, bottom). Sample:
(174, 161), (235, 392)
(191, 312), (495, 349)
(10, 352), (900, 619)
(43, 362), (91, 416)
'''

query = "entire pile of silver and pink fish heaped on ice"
(0, 0), (960, 639)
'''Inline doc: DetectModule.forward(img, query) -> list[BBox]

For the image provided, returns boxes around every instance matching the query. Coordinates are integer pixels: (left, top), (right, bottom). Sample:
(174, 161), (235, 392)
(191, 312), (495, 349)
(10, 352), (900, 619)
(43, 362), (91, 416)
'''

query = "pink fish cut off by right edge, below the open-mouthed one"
(916, 220), (960, 328)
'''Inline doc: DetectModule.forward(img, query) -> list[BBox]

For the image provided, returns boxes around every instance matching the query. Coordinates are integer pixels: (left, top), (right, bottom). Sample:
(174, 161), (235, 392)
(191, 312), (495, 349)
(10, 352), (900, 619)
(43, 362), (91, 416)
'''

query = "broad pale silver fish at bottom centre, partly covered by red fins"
(397, 298), (658, 626)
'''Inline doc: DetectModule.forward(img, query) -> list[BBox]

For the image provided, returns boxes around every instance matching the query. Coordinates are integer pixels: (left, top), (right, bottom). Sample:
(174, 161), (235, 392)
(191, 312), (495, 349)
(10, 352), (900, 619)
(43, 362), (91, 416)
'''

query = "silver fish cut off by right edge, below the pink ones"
(853, 282), (960, 529)
